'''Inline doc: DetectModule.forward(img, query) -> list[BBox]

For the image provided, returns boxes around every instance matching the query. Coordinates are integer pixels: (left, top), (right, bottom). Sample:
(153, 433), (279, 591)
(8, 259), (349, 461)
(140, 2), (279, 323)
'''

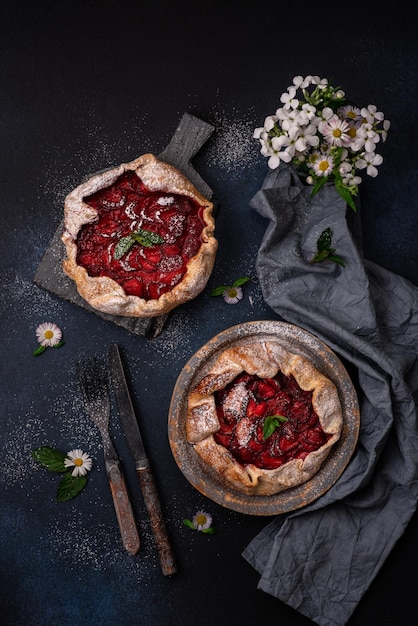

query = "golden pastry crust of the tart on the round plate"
(186, 339), (343, 496)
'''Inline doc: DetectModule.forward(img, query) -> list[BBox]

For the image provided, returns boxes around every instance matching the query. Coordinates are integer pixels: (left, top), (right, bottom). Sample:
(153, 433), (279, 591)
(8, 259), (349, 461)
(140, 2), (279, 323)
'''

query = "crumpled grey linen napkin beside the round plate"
(243, 166), (418, 626)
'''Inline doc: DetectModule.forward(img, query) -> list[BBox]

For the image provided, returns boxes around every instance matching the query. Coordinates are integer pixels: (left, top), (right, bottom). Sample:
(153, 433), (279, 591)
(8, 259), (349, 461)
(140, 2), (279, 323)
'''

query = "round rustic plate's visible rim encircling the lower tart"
(168, 321), (360, 515)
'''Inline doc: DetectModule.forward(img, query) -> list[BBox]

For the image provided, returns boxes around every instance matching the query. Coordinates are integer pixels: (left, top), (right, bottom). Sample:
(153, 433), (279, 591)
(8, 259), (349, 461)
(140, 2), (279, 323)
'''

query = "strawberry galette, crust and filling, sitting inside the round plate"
(186, 338), (343, 495)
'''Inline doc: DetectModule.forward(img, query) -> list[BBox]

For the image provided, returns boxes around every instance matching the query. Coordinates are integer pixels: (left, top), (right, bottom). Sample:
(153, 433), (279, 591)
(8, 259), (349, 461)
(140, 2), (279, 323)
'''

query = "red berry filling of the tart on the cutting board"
(77, 172), (205, 300)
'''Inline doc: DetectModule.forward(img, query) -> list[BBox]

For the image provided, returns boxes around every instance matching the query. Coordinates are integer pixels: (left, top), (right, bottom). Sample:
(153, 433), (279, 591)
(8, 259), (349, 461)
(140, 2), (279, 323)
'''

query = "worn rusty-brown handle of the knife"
(136, 466), (177, 576)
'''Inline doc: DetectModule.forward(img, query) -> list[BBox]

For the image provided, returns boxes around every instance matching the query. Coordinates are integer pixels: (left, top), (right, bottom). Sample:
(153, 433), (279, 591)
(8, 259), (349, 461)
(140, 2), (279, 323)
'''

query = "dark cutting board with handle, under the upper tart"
(34, 113), (216, 337)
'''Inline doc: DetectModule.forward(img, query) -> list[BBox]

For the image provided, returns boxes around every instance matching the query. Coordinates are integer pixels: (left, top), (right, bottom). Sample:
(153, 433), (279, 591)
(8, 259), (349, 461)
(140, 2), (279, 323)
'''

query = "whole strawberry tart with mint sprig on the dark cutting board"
(62, 154), (218, 318)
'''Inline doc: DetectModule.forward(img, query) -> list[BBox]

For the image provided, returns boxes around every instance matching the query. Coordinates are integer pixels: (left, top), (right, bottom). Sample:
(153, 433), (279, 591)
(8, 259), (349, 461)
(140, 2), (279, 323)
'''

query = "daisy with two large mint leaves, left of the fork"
(31, 446), (91, 502)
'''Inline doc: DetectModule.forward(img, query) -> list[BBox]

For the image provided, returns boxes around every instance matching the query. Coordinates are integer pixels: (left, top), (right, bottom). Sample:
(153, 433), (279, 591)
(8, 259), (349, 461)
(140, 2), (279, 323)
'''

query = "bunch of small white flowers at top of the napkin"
(254, 74), (390, 210)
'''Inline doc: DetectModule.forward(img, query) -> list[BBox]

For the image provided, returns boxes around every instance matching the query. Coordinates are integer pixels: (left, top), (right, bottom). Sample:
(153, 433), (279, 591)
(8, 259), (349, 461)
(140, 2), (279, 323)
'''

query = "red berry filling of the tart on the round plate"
(214, 372), (330, 469)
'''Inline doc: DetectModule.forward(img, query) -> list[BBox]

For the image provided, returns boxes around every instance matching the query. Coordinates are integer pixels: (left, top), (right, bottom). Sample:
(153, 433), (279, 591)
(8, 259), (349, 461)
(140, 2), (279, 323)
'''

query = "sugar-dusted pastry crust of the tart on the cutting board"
(61, 154), (218, 318)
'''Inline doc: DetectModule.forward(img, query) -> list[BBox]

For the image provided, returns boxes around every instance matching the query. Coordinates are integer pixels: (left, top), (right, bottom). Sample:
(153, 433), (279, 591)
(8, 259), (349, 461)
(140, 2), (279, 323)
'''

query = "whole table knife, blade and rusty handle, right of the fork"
(108, 344), (177, 576)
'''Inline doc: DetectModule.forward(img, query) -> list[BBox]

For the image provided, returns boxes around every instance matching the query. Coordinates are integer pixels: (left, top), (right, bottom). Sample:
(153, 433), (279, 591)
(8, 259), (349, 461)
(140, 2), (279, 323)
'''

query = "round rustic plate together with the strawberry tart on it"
(169, 321), (359, 515)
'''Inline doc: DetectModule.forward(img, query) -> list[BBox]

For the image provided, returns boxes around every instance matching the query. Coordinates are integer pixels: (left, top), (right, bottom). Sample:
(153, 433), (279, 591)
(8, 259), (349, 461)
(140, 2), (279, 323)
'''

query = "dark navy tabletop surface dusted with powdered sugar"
(0, 0), (418, 626)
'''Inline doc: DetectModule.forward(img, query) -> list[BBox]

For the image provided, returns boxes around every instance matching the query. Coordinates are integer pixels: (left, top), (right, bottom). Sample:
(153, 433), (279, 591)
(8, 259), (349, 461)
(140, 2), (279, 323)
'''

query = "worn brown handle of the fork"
(106, 461), (140, 554)
